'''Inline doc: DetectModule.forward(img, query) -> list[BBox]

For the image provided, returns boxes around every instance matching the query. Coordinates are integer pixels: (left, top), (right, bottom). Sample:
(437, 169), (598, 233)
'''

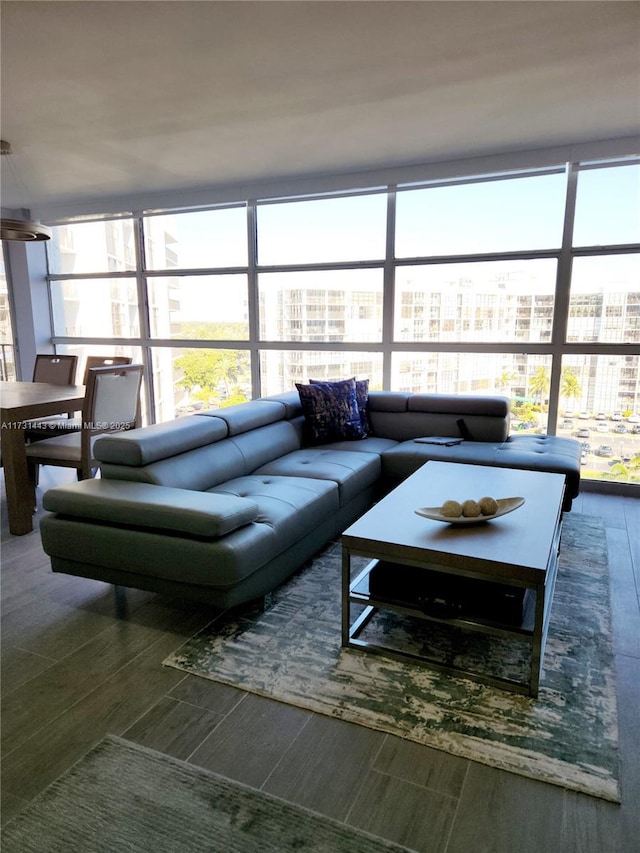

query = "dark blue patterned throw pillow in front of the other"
(296, 379), (366, 444)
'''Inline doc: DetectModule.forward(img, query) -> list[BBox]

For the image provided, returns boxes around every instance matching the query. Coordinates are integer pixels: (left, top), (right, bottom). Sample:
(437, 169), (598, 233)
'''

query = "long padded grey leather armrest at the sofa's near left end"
(43, 479), (258, 539)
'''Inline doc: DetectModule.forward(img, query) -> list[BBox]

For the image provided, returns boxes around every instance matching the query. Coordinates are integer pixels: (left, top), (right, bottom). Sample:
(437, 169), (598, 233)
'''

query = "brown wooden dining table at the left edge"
(0, 382), (85, 536)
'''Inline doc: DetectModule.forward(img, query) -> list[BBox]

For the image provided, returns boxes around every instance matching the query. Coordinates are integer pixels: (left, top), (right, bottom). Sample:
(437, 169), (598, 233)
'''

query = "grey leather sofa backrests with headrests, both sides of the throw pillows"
(95, 391), (509, 491)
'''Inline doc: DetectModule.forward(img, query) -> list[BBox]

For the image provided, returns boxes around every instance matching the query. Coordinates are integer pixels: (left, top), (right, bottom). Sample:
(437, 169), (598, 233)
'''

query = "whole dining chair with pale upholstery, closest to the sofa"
(25, 364), (143, 486)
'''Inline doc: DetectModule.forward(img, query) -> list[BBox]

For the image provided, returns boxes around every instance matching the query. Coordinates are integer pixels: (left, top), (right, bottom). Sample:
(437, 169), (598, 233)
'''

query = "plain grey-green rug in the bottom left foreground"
(2, 736), (406, 853)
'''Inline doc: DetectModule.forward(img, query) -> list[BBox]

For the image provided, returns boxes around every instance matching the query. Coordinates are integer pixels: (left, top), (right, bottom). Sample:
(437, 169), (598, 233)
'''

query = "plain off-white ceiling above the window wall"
(0, 0), (640, 220)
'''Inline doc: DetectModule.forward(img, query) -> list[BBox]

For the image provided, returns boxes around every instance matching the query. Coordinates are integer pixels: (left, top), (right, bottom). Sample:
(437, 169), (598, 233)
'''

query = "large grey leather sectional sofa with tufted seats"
(40, 391), (580, 608)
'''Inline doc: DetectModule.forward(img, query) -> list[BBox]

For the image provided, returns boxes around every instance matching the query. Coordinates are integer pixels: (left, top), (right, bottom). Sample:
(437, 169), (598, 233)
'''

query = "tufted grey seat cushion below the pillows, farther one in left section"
(254, 447), (382, 506)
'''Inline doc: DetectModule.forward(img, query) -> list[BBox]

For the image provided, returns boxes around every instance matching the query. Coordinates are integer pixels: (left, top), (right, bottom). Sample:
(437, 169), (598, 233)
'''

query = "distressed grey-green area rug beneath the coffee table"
(165, 514), (619, 802)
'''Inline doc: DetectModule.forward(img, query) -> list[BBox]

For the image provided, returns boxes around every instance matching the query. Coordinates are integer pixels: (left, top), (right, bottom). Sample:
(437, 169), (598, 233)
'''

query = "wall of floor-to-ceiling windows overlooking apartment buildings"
(42, 156), (640, 482)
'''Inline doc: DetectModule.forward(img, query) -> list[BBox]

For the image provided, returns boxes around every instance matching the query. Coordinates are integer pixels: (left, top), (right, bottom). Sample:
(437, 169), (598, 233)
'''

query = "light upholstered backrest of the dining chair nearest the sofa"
(82, 364), (143, 445)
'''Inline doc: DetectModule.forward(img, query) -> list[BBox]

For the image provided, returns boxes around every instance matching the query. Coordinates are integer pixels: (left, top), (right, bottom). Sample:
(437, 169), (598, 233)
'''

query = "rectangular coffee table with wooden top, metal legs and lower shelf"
(342, 462), (565, 696)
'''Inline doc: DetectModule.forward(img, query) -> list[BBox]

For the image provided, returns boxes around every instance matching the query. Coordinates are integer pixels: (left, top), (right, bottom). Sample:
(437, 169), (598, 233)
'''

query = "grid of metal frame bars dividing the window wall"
(46, 157), (640, 482)
